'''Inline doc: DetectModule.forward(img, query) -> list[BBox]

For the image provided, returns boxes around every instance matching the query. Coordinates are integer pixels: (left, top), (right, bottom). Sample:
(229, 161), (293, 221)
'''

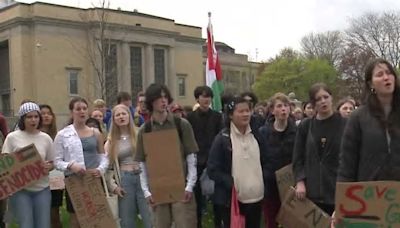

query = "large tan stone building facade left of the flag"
(0, 3), (204, 121)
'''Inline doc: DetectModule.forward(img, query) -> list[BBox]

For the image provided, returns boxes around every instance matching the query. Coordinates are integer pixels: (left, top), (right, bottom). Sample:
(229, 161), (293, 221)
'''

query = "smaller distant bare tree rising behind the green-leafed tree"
(300, 31), (343, 67)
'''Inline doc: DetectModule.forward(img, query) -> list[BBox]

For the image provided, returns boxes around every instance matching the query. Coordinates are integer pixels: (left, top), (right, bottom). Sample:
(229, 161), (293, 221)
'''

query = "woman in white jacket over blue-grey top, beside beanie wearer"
(54, 97), (109, 228)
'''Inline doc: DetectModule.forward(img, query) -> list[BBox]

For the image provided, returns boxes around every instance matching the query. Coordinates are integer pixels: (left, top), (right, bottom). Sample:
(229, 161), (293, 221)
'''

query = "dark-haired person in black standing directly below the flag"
(186, 86), (223, 228)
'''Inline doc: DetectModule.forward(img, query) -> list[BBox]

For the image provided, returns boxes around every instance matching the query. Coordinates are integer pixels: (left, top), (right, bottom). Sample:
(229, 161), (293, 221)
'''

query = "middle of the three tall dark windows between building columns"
(130, 47), (143, 101)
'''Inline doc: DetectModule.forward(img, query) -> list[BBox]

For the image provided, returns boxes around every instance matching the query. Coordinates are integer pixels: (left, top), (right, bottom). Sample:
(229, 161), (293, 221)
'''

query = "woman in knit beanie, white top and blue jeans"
(2, 102), (54, 228)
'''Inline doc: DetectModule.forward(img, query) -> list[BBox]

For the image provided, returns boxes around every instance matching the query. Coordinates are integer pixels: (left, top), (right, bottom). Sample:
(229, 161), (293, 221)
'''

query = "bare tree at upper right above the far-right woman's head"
(345, 11), (400, 68)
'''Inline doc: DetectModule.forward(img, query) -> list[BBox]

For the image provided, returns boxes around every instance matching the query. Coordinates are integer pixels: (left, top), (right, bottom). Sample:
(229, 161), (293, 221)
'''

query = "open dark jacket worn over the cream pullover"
(207, 128), (266, 206)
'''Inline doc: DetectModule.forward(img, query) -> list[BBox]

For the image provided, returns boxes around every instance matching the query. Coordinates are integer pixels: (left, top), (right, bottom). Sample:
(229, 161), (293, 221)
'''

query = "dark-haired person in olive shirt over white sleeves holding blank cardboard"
(135, 84), (199, 228)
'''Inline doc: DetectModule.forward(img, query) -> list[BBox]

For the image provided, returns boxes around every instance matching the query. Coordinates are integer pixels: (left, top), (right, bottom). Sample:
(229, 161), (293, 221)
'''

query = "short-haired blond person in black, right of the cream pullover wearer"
(259, 93), (297, 228)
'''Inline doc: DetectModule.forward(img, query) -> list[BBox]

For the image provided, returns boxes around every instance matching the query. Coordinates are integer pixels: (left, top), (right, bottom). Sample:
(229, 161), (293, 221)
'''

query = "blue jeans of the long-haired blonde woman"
(118, 170), (152, 228)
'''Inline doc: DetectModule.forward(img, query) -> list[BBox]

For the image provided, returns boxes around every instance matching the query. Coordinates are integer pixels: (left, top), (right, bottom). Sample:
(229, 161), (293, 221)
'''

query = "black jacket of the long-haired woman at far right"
(338, 106), (400, 182)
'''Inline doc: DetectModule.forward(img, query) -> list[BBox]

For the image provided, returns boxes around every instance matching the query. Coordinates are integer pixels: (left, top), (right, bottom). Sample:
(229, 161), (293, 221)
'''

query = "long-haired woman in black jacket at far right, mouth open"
(338, 59), (400, 182)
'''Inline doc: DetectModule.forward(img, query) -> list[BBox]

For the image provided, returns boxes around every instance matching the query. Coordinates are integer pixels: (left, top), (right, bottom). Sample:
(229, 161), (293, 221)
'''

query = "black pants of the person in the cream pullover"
(214, 201), (262, 228)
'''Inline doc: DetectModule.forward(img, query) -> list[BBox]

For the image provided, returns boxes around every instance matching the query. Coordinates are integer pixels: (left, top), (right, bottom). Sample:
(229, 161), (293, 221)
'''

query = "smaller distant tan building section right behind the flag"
(203, 42), (261, 94)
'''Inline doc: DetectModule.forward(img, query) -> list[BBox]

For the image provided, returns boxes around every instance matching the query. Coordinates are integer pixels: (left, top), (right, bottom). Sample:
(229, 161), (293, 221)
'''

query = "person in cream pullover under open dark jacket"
(207, 97), (265, 228)
